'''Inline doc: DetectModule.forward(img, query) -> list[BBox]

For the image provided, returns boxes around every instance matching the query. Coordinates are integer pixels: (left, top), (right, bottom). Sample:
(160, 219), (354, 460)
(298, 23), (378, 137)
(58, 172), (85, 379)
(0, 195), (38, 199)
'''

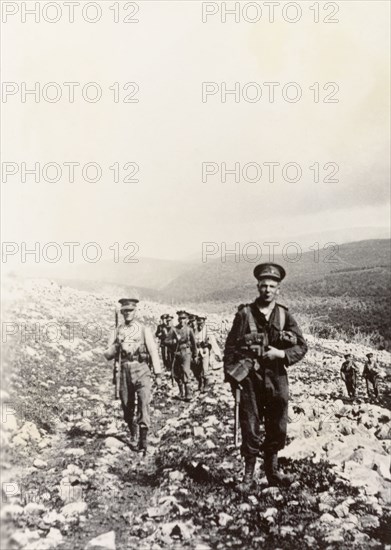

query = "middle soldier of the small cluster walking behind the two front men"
(165, 311), (197, 401)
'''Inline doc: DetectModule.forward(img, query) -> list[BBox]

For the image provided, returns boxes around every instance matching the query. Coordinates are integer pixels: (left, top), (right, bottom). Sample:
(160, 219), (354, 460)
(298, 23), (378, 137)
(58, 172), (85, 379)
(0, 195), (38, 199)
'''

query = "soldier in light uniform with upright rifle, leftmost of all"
(104, 298), (161, 455)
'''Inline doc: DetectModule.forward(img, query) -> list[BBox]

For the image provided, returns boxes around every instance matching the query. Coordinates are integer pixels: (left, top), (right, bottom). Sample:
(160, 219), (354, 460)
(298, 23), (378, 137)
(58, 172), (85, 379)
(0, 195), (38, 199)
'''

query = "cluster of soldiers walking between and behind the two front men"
(155, 310), (221, 401)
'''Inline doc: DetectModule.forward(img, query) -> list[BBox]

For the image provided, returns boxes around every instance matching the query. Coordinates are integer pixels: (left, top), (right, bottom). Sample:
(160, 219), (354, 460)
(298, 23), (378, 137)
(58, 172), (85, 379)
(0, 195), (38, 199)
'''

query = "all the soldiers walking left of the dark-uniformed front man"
(104, 298), (221, 455)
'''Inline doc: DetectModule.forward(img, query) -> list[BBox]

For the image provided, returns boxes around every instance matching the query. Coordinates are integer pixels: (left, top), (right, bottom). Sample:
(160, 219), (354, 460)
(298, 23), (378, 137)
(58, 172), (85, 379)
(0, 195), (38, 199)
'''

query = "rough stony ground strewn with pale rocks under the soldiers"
(1, 281), (391, 550)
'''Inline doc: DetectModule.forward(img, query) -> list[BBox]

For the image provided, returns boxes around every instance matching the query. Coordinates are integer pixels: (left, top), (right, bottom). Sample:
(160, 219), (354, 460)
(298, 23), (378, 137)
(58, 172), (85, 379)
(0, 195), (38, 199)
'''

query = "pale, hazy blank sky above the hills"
(2, 0), (390, 266)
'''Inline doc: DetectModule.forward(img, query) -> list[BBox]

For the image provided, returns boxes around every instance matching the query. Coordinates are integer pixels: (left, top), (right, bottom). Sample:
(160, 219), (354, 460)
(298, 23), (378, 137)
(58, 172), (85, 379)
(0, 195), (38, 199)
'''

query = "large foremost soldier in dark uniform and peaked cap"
(224, 263), (307, 491)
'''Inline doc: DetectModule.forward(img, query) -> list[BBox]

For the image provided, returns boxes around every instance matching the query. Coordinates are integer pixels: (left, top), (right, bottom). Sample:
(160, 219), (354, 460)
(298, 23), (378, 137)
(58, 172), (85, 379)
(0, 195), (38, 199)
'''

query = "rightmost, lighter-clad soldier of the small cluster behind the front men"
(195, 315), (221, 393)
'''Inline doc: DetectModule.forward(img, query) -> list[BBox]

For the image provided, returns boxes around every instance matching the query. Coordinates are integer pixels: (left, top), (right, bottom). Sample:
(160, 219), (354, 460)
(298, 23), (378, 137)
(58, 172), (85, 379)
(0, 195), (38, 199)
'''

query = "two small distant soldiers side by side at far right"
(341, 353), (380, 399)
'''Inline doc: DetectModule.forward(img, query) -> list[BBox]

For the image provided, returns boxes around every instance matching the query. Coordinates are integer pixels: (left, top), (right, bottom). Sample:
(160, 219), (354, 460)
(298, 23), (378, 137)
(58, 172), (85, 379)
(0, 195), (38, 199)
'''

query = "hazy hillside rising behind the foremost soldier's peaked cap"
(162, 239), (391, 302)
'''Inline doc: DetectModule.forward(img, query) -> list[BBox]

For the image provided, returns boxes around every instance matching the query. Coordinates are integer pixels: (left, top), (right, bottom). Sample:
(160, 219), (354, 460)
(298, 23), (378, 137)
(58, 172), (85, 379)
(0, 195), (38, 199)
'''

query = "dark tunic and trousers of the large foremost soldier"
(224, 300), (307, 458)
